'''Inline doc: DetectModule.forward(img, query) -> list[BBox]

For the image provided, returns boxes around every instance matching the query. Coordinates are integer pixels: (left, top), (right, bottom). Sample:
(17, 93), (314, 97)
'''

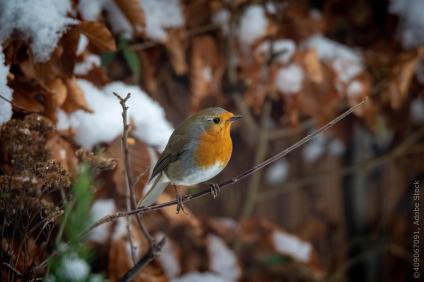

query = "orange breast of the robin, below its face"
(195, 126), (233, 168)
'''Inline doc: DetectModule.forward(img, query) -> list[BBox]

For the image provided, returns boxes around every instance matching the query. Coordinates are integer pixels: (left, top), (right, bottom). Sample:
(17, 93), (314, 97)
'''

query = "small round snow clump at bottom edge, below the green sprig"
(58, 256), (90, 281)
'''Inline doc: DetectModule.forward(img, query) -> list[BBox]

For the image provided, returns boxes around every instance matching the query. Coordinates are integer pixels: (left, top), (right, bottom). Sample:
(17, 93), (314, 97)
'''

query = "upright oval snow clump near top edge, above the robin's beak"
(239, 5), (268, 48)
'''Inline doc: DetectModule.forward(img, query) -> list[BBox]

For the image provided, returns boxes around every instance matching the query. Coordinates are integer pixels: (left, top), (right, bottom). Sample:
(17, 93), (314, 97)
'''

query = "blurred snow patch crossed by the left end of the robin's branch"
(88, 199), (116, 243)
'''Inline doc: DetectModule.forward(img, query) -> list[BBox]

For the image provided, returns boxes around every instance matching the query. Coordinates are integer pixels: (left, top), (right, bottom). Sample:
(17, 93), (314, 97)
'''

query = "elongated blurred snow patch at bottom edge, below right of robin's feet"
(207, 234), (241, 281)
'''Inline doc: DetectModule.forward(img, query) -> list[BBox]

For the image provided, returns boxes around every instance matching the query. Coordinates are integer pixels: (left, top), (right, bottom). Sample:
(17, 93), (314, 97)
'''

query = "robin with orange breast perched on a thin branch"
(139, 108), (241, 212)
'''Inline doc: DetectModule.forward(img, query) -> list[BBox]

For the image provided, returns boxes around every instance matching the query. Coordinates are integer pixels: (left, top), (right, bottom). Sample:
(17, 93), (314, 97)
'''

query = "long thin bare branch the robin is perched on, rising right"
(82, 98), (368, 229)
